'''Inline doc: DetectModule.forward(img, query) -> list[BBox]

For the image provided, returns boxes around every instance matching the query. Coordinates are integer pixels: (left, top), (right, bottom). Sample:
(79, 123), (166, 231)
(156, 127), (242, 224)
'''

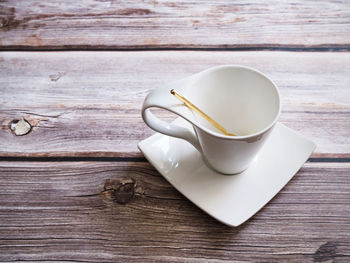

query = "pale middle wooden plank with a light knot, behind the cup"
(0, 51), (350, 157)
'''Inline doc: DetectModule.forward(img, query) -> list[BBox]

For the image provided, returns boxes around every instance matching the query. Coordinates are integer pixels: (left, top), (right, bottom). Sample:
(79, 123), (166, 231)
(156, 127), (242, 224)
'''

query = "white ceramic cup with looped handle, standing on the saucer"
(142, 65), (281, 174)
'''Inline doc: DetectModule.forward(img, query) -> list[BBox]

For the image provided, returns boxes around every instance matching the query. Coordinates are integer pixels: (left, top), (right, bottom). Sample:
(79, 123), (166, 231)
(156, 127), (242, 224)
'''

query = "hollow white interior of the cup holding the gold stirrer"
(185, 66), (280, 136)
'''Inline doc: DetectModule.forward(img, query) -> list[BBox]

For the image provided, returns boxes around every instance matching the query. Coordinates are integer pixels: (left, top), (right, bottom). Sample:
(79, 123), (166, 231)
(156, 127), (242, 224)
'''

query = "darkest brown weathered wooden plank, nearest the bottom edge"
(0, 162), (350, 262)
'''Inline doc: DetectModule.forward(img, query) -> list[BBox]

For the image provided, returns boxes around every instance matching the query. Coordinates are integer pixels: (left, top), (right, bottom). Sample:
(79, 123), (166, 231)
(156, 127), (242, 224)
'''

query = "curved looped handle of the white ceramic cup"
(142, 88), (202, 152)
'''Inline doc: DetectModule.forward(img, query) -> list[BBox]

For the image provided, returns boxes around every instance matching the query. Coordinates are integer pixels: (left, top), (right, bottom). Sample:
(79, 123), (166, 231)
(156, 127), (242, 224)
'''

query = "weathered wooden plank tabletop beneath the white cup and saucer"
(0, 0), (350, 262)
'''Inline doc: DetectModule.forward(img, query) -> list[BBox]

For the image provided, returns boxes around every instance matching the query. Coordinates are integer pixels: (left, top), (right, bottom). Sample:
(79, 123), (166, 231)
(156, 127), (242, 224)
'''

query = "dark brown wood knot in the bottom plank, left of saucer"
(104, 178), (136, 205)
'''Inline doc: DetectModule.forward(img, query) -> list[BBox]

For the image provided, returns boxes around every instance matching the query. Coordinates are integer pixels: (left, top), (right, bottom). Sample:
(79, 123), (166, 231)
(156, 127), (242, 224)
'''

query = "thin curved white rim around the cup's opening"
(192, 64), (282, 140)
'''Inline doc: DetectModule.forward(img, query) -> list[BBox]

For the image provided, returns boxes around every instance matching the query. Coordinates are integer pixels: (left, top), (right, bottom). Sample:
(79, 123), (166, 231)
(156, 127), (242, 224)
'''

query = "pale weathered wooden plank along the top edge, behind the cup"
(0, 0), (350, 49)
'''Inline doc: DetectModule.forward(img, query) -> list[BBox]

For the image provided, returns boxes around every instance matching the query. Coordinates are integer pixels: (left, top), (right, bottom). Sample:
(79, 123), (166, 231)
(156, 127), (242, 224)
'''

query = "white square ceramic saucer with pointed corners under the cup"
(138, 118), (316, 226)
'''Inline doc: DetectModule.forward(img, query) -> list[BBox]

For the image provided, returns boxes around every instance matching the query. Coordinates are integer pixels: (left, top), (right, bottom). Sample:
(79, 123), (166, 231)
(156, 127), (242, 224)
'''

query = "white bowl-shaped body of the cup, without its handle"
(185, 66), (280, 174)
